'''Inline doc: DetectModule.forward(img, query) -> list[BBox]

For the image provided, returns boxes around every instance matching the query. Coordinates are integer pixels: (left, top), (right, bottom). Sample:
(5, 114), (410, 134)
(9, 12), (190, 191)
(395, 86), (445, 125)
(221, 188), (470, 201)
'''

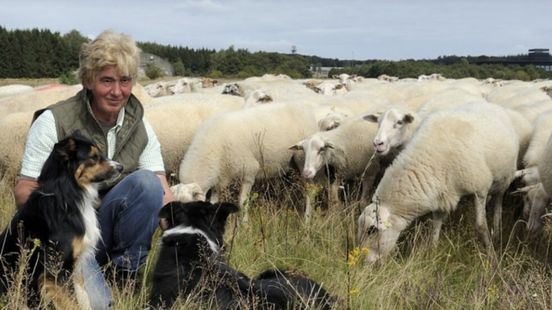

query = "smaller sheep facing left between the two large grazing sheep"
(290, 112), (377, 215)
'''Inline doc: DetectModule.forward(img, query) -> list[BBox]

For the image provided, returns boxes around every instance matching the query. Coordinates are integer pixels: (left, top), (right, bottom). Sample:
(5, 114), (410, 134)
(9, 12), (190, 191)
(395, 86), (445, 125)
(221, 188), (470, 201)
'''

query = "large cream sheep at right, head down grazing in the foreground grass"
(357, 104), (519, 262)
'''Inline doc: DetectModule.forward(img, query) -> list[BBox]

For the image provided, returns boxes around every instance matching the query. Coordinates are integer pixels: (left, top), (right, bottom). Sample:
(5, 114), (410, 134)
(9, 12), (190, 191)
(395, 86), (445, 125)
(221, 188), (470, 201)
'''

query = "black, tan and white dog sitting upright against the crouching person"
(0, 131), (122, 309)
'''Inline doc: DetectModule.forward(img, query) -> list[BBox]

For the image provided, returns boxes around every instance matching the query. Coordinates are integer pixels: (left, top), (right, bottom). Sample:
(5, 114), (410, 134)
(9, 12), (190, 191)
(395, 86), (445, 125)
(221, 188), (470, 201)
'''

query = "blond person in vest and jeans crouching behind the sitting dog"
(15, 31), (174, 308)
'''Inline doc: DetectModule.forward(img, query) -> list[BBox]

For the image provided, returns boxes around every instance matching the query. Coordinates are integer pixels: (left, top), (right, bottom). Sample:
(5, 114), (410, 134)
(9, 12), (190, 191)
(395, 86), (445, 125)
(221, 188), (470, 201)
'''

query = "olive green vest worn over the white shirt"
(33, 90), (148, 190)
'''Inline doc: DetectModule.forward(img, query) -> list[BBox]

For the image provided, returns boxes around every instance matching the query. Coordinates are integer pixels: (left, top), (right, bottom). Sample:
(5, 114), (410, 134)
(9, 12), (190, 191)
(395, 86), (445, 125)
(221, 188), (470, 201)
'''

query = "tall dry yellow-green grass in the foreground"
(0, 174), (552, 309)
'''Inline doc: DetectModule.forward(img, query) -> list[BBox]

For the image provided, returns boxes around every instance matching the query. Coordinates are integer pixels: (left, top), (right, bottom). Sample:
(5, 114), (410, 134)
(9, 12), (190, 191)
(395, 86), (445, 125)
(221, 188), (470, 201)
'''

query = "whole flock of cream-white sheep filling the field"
(0, 74), (552, 261)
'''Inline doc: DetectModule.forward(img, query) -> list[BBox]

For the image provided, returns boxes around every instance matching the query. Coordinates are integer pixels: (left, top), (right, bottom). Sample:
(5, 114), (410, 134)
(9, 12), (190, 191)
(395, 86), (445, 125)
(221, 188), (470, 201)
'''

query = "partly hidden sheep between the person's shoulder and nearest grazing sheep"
(144, 93), (243, 173)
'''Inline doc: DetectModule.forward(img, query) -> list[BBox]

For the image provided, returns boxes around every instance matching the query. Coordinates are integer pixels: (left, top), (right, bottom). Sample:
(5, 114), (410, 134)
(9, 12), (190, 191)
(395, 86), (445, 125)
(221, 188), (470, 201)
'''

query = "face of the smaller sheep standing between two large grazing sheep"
(290, 135), (334, 179)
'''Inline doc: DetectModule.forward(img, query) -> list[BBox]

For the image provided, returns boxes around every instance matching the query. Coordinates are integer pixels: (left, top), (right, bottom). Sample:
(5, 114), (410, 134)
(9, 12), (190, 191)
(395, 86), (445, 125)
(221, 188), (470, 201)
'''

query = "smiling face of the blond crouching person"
(90, 66), (132, 115)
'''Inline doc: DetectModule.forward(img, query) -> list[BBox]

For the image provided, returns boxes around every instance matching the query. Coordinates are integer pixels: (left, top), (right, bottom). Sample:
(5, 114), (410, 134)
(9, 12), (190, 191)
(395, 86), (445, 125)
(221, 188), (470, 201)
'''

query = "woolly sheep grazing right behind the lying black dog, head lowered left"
(172, 103), (317, 216)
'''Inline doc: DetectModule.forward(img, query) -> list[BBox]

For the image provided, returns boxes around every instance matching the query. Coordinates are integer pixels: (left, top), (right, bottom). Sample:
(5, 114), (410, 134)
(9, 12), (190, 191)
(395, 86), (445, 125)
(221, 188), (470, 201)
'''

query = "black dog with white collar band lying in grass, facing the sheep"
(149, 201), (335, 309)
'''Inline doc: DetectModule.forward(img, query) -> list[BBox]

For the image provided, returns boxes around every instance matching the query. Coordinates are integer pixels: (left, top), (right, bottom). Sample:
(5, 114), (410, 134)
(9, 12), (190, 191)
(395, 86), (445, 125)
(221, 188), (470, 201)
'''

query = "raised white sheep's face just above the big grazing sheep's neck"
(364, 109), (414, 155)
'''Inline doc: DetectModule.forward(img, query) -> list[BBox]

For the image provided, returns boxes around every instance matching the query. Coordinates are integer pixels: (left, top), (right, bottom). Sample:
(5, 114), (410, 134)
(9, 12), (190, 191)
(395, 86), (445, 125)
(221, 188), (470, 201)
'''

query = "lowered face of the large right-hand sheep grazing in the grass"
(357, 203), (400, 263)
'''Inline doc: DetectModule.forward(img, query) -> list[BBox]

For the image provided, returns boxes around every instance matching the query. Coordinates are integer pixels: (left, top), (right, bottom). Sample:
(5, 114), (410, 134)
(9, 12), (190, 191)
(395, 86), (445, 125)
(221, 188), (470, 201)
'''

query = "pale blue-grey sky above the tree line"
(0, 0), (552, 60)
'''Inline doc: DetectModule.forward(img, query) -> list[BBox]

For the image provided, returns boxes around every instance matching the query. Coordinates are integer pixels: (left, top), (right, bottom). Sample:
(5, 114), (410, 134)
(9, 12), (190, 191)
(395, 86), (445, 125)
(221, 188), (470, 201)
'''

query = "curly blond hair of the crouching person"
(79, 30), (140, 88)
